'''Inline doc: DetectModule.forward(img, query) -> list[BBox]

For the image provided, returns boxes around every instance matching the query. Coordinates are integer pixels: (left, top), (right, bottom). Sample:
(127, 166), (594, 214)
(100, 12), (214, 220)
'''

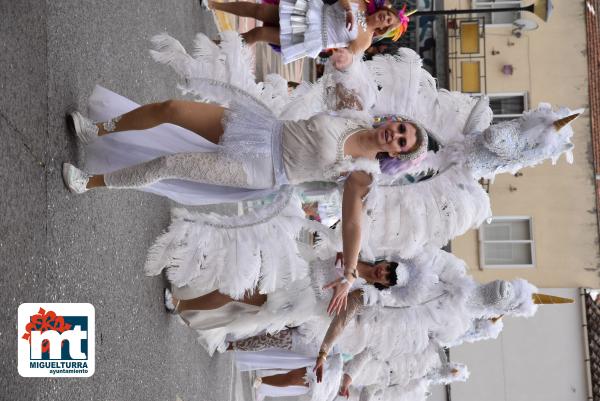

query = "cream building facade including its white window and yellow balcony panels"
(444, 0), (600, 288)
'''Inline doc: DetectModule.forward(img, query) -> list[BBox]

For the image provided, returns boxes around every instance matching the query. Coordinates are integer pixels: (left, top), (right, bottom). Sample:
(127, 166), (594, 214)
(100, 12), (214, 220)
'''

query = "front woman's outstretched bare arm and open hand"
(325, 171), (373, 313)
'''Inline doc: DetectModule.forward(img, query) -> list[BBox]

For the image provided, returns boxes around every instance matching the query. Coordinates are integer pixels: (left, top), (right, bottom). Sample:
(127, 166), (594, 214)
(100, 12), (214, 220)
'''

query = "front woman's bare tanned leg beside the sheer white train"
(96, 100), (225, 143)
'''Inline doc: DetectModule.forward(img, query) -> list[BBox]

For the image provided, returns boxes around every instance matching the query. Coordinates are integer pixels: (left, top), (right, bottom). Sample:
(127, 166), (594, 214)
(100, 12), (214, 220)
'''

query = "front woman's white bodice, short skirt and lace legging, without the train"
(89, 92), (379, 198)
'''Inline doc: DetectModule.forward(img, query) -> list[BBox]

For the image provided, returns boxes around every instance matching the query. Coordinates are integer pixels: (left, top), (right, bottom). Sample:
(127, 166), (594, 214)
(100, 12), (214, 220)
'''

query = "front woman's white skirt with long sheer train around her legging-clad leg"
(85, 86), (287, 205)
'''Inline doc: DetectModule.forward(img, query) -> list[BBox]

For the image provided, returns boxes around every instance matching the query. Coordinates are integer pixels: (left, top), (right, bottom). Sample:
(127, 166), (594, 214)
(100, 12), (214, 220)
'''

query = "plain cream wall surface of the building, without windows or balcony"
(446, 0), (600, 288)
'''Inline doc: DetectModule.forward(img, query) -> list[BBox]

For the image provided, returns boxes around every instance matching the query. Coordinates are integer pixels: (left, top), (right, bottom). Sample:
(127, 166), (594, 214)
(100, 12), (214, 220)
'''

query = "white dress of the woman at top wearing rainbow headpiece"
(279, 0), (358, 64)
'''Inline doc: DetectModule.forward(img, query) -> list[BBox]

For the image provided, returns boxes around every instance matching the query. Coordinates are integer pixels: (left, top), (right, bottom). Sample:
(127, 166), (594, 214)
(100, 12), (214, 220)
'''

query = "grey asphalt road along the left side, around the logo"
(0, 0), (253, 401)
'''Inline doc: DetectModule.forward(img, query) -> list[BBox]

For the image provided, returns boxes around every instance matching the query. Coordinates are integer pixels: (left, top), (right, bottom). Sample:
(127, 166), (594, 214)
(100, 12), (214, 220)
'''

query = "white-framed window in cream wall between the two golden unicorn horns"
(479, 217), (535, 268)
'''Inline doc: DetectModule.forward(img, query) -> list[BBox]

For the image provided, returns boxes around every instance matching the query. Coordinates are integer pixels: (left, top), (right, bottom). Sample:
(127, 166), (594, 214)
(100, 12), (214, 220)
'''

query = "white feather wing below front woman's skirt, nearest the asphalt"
(145, 188), (314, 299)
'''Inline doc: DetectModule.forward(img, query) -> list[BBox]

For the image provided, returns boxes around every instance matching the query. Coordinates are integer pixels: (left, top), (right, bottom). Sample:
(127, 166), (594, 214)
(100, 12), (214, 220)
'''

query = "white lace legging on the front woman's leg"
(104, 152), (274, 189)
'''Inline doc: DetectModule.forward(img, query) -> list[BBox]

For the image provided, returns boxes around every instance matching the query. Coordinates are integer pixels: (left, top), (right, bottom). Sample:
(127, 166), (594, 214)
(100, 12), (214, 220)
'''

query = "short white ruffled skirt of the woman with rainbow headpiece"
(279, 0), (323, 64)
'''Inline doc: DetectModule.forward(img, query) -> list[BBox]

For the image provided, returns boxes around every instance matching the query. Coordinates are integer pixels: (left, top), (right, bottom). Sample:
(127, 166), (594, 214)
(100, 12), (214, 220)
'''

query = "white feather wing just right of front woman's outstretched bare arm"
(363, 165), (492, 258)
